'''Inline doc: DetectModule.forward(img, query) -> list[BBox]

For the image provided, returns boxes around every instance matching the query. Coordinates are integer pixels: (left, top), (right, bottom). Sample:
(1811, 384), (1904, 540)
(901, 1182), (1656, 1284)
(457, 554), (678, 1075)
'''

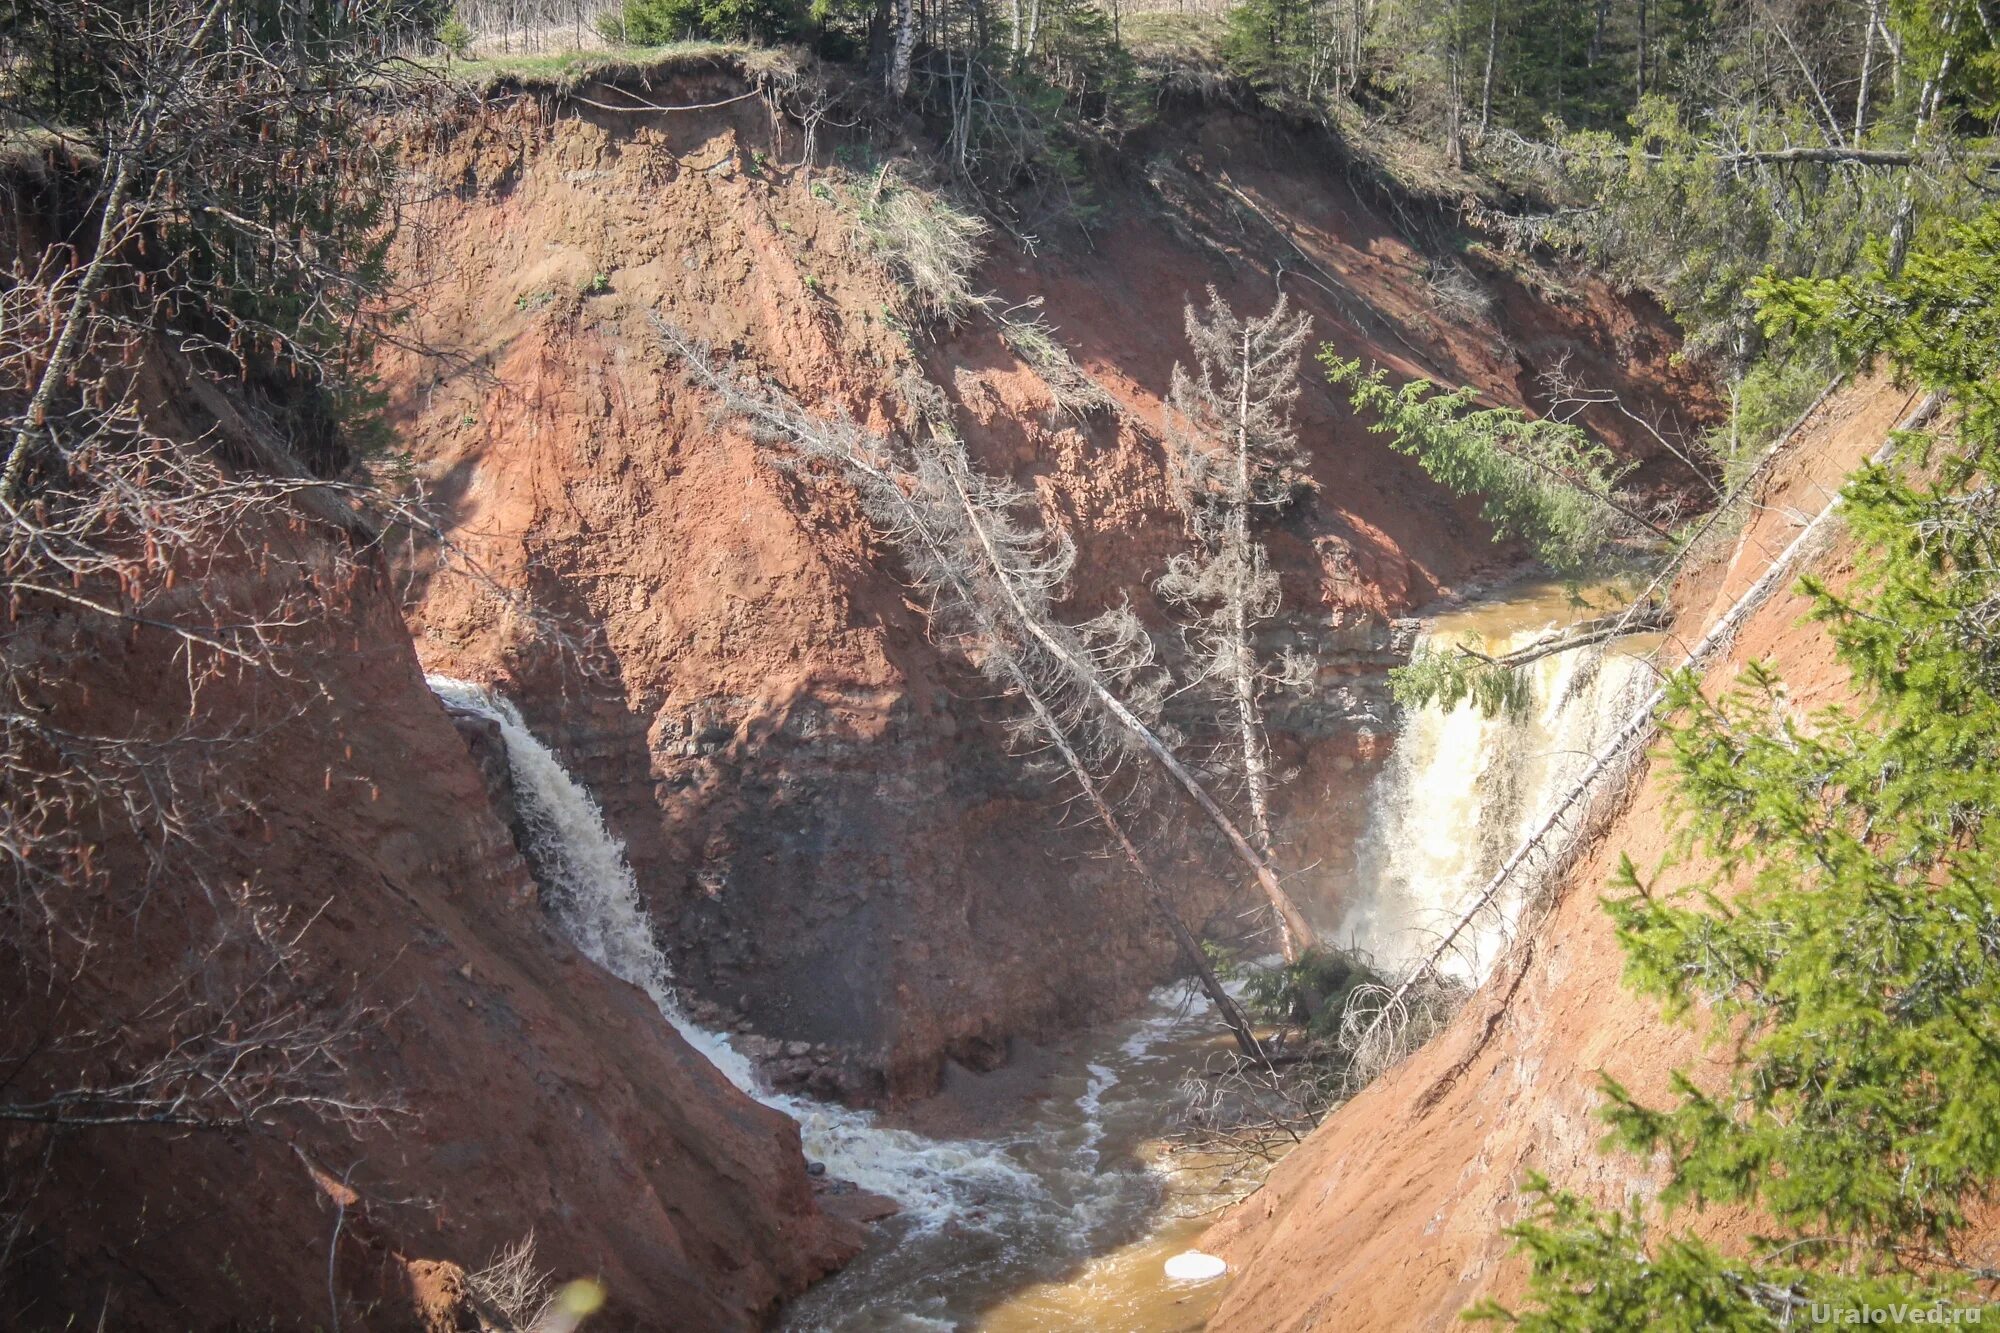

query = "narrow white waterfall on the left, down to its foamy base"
(428, 677), (1042, 1229)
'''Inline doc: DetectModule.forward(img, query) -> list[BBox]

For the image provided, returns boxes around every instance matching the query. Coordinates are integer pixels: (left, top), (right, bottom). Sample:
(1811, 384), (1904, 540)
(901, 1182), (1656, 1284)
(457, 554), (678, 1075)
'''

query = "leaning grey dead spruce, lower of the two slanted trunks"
(660, 322), (1266, 1063)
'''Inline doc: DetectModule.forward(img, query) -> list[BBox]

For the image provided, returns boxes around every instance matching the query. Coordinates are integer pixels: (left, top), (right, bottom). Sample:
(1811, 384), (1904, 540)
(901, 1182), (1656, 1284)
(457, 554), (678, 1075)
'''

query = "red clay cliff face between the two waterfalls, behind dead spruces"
(384, 59), (1712, 1099)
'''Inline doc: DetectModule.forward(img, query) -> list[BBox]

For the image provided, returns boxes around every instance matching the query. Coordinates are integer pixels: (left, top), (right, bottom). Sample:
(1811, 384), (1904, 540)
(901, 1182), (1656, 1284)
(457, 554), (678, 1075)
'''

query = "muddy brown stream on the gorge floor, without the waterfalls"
(782, 987), (1254, 1333)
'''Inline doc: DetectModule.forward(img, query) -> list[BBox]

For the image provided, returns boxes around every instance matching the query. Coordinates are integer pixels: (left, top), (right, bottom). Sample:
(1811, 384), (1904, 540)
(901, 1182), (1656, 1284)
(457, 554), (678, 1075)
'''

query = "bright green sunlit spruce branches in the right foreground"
(1476, 202), (2000, 1329)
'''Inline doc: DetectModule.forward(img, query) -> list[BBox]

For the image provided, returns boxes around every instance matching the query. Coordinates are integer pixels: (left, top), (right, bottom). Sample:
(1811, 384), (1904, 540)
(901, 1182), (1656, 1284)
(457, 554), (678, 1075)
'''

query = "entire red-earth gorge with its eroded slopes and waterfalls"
(0, 36), (1944, 1333)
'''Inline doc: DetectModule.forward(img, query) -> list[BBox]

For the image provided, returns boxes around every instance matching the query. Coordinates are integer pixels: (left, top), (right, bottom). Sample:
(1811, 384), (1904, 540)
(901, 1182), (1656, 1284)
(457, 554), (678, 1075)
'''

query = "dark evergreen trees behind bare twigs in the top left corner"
(0, 0), (430, 474)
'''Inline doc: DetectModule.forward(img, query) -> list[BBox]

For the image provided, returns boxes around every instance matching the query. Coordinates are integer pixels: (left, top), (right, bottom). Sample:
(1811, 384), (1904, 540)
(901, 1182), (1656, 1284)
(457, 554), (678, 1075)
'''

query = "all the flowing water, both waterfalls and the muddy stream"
(430, 588), (1664, 1333)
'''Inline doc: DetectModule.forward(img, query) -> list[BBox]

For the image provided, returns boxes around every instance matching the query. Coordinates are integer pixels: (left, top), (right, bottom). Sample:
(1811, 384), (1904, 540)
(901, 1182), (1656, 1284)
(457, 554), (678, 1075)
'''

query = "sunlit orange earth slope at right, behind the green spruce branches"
(1204, 382), (1914, 1333)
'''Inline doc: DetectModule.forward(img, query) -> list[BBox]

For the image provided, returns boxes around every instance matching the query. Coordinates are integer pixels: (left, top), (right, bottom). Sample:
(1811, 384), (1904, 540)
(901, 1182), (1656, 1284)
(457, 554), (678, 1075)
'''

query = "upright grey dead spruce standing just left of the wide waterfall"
(1158, 288), (1314, 961)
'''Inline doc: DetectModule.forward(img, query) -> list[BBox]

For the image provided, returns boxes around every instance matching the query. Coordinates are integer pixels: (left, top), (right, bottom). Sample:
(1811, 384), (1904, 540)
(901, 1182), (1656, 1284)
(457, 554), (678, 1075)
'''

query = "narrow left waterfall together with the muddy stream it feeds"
(430, 677), (1248, 1333)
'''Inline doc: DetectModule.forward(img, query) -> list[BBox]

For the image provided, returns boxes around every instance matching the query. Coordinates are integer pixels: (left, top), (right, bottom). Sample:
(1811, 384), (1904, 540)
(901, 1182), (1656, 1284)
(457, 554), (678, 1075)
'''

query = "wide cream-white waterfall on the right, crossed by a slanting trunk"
(1336, 588), (1646, 985)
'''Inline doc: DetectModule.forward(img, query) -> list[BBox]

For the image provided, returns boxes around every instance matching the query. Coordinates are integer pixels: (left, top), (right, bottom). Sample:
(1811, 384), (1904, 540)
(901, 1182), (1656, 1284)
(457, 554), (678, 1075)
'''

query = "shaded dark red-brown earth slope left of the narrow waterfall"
(0, 492), (858, 1333)
